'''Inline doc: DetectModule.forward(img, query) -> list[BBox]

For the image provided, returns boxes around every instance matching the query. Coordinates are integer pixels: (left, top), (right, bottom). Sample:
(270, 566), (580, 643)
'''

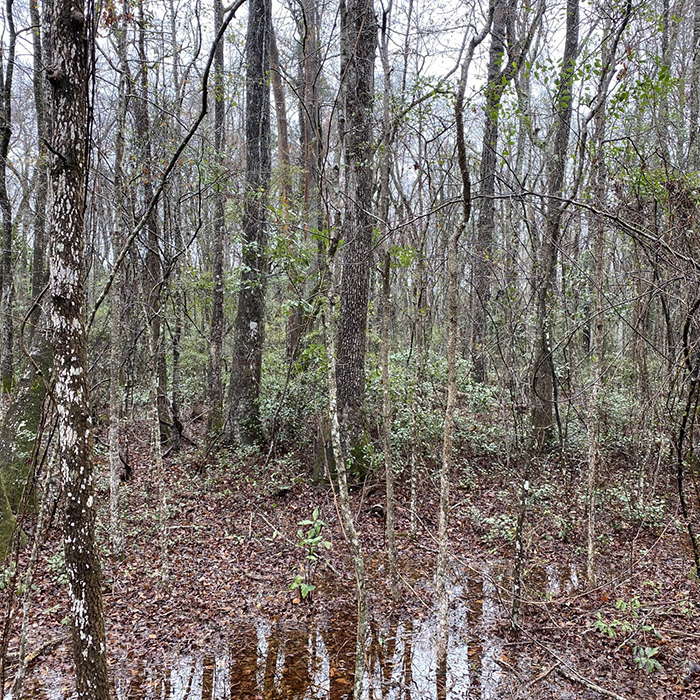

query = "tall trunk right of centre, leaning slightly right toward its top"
(531, 0), (579, 447)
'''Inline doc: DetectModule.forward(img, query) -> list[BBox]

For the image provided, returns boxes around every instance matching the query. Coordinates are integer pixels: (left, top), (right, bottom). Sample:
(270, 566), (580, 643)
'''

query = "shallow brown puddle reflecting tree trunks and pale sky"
(16, 566), (575, 700)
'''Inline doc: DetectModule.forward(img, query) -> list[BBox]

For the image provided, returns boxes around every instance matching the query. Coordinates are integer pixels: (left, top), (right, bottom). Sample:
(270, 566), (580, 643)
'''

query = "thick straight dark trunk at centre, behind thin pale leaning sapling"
(337, 0), (377, 474)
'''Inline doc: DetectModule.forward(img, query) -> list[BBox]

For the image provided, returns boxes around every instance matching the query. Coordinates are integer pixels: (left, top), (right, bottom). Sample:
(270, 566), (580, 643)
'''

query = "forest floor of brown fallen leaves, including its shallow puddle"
(7, 422), (700, 700)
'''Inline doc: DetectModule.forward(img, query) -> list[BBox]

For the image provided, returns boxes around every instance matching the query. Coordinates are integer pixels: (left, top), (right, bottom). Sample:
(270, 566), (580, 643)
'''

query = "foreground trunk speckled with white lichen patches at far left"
(48, 0), (109, 700)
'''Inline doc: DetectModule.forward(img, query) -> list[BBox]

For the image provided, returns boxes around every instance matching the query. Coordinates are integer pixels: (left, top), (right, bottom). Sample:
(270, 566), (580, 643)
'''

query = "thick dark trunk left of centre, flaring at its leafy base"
(229, 0), (272, 444)
